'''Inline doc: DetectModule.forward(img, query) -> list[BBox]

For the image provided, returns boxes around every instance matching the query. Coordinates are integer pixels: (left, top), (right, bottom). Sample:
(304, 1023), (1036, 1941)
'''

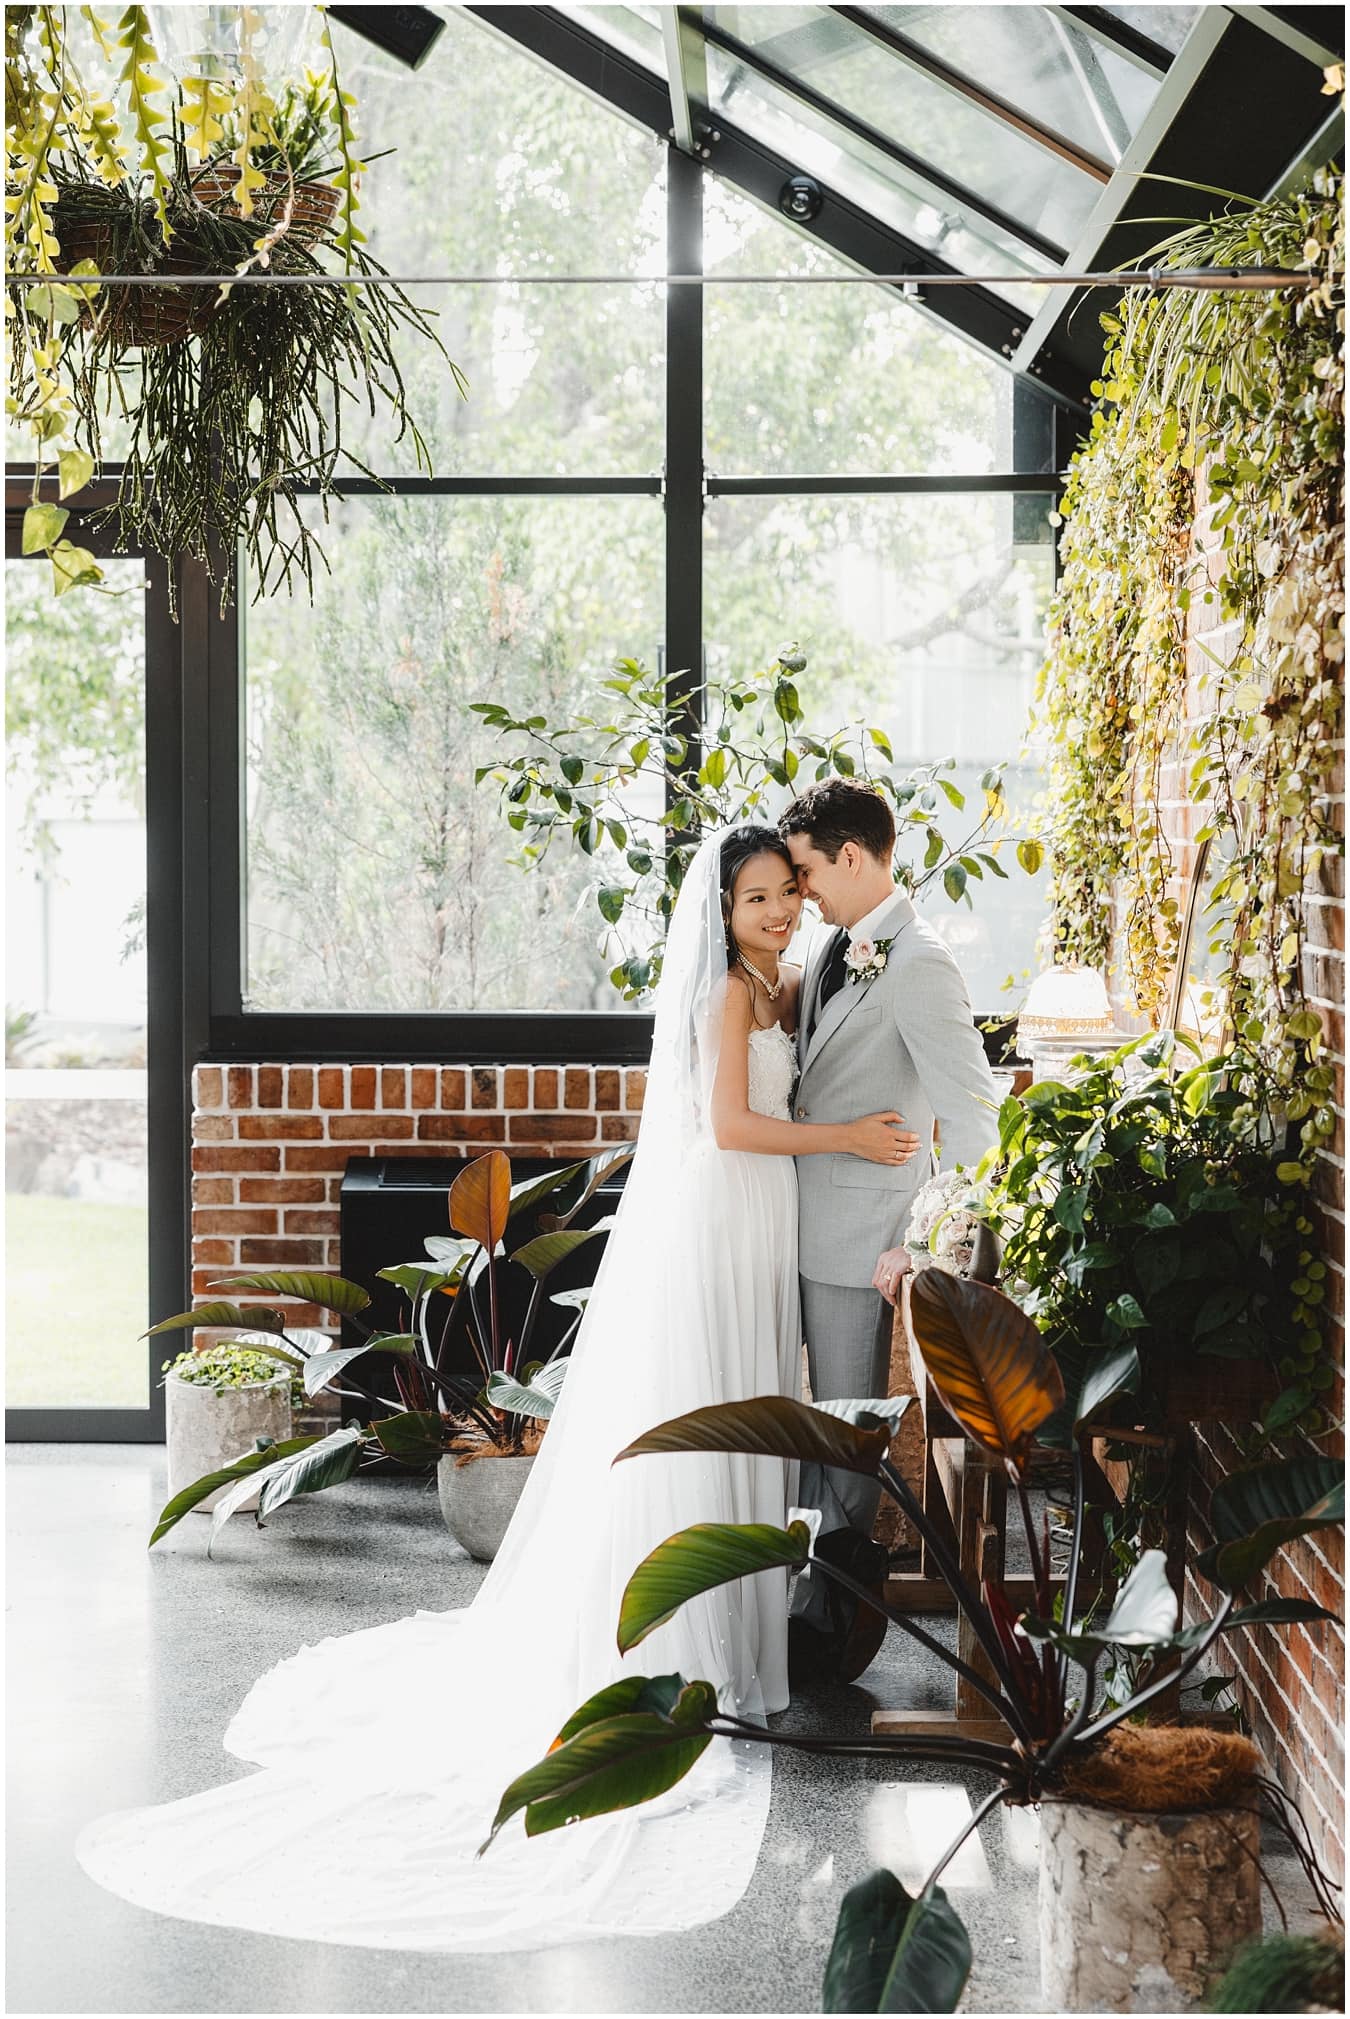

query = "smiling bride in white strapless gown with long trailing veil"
(77, 826), (918, 1952)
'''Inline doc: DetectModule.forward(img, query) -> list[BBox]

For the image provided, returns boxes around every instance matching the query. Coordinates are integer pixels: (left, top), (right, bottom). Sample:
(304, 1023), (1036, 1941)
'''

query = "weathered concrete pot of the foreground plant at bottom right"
(1039, 1793), (1261, 2013)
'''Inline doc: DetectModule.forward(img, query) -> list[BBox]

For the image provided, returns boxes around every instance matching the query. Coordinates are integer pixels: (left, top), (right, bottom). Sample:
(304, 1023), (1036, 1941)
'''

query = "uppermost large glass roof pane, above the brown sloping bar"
(864, 6), (1170, 166)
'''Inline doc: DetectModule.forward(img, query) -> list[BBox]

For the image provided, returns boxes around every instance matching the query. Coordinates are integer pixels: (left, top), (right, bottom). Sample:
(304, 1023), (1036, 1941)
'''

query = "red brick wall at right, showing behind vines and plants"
(1116, 480), (1346, 1880)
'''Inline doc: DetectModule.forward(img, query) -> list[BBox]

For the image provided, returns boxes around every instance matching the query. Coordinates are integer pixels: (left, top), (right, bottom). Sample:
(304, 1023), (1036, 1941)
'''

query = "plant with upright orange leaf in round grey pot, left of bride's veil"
(149, 1145), (634, 1559)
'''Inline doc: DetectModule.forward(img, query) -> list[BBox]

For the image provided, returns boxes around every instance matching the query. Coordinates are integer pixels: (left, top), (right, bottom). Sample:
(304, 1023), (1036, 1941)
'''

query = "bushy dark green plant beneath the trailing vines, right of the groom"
(979, 1032), (1332, 1436)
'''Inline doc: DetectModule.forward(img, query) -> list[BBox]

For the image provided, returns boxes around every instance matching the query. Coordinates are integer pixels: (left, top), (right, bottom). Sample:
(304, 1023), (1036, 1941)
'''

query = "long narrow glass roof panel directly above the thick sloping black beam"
(706, 42), (1053, 313)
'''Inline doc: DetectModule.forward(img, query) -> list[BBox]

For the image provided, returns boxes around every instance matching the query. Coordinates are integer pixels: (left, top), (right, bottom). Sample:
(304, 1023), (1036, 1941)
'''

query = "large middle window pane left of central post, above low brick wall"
(244, 497), (664, 1012)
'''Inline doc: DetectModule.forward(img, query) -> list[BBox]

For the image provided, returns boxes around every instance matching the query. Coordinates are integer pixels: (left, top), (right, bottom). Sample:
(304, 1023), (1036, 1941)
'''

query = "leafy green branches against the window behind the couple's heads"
(470, 646), (1041, 1001)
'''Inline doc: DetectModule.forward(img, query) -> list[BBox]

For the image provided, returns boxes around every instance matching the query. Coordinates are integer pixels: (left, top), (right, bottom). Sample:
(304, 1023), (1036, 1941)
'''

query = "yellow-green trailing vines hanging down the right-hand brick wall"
(1039, 170), (1344, 1183)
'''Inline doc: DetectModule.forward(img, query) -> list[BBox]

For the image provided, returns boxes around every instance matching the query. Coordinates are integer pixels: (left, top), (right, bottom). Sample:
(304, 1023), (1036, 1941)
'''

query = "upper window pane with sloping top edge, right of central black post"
(704, 182), (1013, 476)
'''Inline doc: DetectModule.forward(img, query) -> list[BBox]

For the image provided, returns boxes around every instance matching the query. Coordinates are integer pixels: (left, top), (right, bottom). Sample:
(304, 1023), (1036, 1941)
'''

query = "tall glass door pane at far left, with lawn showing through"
(4, 559), (149, 1409)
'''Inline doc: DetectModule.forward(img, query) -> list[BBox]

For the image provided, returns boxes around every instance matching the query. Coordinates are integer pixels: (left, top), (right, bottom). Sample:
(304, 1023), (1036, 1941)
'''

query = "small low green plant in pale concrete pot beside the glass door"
(163, 1337), (305, 1514)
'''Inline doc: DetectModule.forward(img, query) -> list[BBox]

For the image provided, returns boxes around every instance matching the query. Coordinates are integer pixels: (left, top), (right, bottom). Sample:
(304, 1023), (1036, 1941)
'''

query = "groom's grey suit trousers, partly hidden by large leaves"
(791, 1276), (894, 1631)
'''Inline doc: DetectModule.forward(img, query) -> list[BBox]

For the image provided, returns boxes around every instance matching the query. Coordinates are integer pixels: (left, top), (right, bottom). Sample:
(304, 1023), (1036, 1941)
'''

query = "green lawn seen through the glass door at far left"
(4, 1191), (149, 1409)
